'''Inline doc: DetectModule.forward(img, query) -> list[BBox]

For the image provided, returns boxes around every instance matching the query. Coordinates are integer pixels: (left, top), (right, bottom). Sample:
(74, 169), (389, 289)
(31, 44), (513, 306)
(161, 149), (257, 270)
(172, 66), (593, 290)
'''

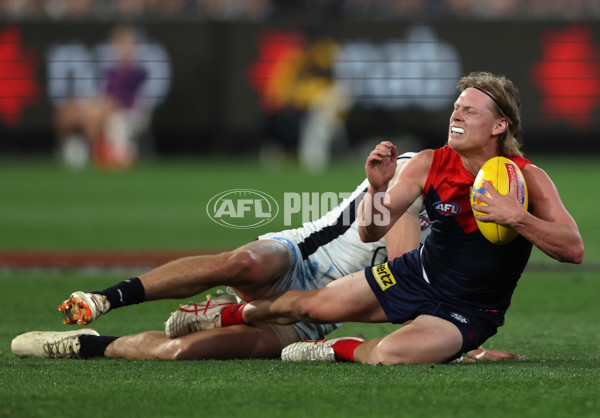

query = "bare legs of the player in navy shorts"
(243, 272), (462, 364)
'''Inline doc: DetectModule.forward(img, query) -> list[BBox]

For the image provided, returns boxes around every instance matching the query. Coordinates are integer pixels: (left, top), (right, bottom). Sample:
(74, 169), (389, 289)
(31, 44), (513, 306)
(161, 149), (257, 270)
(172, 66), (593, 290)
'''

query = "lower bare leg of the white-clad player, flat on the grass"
(105, 324), (288, 360)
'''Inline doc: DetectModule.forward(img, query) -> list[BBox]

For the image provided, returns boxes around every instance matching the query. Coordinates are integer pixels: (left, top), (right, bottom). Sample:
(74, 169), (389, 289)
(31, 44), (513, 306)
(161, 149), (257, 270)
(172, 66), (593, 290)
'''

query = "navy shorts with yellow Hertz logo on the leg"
(365, 250), (504, 353)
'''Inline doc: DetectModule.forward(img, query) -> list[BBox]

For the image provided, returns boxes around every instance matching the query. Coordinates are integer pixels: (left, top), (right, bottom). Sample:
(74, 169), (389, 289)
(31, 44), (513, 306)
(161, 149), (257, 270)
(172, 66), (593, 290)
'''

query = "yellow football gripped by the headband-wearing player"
(471, 157), (528, 245)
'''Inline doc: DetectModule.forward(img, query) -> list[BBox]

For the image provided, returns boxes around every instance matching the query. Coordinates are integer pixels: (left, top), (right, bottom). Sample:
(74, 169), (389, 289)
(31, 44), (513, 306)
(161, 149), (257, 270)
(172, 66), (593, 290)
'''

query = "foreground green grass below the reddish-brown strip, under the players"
(0, 271), (600, 417)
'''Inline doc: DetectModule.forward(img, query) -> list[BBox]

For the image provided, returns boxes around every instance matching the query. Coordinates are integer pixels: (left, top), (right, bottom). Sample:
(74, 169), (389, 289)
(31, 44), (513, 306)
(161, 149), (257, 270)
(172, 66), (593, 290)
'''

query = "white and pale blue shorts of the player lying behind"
(259, 231), (342, 344)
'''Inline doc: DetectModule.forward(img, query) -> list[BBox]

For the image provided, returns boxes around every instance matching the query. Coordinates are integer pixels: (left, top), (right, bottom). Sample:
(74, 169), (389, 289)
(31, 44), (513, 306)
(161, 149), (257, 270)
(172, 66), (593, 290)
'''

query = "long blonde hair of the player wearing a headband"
(457, 71), (523, 156)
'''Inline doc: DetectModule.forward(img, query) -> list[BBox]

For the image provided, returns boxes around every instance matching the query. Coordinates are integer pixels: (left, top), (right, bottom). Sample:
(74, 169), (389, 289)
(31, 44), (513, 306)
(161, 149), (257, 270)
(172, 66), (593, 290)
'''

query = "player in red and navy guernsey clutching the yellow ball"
(37, 73), (584, 364)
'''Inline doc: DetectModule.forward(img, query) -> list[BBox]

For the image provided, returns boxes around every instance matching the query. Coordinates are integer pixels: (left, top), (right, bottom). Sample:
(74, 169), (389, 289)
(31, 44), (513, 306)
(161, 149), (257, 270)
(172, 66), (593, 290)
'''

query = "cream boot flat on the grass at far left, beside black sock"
(10, 328), (100, 359)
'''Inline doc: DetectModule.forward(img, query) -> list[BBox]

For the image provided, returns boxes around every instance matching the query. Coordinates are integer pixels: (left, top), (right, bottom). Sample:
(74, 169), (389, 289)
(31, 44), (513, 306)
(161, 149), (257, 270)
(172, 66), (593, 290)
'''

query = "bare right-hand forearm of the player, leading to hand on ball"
(511, 211), (584, 264)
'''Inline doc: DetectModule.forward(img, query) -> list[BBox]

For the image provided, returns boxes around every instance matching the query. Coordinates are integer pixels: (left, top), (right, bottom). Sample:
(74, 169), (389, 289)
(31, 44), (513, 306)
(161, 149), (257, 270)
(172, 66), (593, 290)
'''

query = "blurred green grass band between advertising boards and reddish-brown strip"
(0, 157), (600, 261)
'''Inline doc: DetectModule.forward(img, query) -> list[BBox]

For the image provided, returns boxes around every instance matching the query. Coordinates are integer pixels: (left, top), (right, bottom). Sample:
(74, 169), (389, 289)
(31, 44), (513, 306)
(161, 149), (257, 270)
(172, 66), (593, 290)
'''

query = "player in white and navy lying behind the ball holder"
(12, 154), (521, 360)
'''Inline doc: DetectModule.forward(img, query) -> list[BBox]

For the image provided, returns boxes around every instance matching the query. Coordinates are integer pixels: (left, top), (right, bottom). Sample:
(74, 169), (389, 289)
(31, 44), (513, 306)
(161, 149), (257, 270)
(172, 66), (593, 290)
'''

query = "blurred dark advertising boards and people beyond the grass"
(0, 0), (600, 170)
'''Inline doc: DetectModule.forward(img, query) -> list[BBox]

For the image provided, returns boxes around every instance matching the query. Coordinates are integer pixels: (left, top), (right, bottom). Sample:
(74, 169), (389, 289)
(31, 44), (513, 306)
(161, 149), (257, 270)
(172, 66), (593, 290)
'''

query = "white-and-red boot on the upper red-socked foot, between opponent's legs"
(165, 290), (237, 338)
